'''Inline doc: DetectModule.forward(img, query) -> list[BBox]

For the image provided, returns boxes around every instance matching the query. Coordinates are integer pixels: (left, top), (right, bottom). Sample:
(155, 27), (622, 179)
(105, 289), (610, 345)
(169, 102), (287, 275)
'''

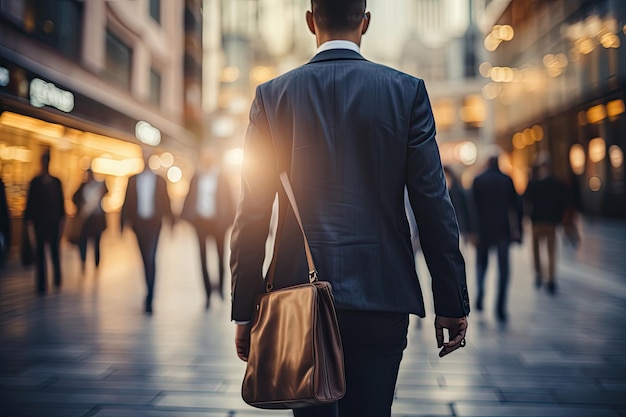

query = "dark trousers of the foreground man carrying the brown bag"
(293, 310), (409, 417)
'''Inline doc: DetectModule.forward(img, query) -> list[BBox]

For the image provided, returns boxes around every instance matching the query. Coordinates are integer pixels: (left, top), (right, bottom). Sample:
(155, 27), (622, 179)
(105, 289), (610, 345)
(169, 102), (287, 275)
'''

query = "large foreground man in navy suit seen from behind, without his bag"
(231, 0), (469, 417)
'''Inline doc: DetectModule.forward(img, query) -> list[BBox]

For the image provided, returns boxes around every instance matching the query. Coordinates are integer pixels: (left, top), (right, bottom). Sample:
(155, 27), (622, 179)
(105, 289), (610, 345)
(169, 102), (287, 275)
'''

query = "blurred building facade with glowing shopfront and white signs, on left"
(0, 0), (202, 249)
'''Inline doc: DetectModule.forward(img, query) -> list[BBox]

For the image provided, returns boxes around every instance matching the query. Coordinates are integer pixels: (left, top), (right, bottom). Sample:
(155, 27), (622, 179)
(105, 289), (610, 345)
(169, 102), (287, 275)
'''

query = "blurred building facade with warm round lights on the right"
(481, 0), (626, 217)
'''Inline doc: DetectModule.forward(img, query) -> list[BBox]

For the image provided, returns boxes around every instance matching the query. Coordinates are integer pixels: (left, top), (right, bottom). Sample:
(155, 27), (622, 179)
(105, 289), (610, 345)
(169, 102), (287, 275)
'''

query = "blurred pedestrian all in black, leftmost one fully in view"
(24, 152), (65, 294)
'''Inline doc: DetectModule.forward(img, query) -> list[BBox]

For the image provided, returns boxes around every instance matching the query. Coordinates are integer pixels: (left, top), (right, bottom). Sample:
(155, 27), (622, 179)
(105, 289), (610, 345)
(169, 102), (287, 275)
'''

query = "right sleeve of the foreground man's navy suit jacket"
(406, 80), (469, 317)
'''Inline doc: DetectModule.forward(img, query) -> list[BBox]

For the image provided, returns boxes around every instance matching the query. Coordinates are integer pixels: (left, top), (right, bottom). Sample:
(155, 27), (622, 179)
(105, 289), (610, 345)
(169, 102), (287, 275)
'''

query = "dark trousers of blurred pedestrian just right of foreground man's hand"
(476, 237), (509, 318)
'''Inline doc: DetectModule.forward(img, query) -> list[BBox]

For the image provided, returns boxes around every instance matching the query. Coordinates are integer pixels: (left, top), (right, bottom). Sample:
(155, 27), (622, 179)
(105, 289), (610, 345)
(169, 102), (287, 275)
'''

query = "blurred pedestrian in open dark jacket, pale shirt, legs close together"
(121, 149), (174, 314)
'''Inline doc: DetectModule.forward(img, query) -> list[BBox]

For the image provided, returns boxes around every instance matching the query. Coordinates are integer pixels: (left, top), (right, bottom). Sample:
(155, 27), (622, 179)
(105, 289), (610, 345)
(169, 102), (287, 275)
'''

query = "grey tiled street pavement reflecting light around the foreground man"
(0, 221), (626, 417)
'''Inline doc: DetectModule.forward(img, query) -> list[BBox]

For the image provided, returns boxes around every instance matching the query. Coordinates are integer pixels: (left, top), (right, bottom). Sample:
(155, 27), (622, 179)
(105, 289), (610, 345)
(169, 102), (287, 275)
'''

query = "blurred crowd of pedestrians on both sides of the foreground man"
(0, 148), (579, 321)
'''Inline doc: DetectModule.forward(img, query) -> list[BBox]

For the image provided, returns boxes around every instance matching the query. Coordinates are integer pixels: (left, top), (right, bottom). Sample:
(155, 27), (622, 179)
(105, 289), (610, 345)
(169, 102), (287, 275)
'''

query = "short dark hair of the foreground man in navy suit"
(311, 0), (366, 32)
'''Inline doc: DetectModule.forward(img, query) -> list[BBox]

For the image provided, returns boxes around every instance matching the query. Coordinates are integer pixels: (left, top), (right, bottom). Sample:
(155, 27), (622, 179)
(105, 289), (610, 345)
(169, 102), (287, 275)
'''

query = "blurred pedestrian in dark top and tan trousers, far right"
(524, 160), (569, 294)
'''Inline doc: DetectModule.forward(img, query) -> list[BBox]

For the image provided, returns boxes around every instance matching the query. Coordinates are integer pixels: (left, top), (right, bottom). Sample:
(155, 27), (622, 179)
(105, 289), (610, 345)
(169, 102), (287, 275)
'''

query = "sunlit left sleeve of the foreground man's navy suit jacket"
(230, 88), (278, 321)
